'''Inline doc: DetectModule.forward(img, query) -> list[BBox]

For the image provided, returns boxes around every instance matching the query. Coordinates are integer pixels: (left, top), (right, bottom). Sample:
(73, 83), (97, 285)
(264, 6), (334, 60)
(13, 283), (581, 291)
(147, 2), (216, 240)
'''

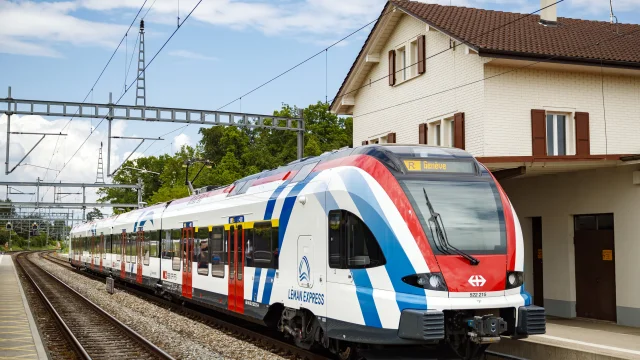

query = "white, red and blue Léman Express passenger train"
(69, 144), (546, 359)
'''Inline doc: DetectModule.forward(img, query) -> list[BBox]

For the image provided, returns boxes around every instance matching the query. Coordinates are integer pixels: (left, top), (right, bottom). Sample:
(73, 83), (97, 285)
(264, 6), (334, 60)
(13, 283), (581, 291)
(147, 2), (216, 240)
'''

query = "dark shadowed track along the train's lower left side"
(41, 253), (332, 360)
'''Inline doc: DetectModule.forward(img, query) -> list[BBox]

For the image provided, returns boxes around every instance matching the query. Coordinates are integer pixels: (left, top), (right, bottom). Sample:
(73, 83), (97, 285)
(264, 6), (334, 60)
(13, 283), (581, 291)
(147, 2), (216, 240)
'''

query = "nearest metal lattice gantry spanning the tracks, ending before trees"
(0, 87), (305, 176)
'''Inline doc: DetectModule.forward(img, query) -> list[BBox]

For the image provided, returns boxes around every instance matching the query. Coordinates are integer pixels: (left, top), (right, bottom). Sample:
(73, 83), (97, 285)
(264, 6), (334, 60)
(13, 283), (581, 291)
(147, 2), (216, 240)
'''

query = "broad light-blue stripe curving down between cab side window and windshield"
(341, 169), (427, 311)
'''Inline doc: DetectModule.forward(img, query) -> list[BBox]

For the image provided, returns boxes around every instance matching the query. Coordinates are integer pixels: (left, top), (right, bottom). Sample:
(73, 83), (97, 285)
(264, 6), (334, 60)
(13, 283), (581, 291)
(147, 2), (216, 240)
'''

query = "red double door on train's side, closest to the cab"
(227, 224), (244, 314)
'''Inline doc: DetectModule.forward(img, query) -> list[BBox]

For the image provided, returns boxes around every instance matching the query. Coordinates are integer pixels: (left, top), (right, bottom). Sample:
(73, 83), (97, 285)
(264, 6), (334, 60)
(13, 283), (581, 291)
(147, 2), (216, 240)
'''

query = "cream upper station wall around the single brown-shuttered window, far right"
(484, 63), (640, 156)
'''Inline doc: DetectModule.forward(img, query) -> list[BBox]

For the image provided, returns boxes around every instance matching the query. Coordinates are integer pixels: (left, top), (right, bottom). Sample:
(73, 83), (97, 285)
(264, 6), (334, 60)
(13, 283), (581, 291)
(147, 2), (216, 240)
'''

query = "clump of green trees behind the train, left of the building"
(98, 102), (353, 207)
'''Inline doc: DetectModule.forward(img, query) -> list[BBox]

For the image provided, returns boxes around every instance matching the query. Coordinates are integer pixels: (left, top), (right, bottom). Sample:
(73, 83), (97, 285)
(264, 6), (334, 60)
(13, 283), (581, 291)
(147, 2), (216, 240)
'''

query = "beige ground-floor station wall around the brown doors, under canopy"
(503, 165), (640, 327)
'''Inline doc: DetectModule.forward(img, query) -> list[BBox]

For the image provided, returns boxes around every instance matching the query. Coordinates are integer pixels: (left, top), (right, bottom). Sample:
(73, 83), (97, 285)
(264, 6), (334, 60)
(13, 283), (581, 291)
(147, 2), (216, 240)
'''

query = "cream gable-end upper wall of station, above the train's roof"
(353, 15), (488, 156)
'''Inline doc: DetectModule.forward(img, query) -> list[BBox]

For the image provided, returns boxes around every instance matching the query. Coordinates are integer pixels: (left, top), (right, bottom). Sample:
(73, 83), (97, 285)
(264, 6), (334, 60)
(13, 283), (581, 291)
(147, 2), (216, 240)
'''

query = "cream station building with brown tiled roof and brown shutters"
(331, 0), (640, 327)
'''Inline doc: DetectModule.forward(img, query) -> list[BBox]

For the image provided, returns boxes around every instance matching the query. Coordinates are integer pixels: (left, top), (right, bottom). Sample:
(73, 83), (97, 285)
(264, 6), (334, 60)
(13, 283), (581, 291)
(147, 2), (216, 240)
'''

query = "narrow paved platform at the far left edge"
(0, 254), (47, 360)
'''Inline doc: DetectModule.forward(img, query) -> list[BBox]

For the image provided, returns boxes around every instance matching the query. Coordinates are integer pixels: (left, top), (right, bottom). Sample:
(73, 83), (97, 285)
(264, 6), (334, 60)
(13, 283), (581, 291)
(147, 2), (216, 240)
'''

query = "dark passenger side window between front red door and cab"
(251, 222), (278, 269)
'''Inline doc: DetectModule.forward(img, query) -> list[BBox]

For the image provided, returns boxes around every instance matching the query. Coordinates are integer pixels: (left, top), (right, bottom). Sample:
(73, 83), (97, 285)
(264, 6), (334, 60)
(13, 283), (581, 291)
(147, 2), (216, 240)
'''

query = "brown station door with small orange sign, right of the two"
(574, 215), (616, 321)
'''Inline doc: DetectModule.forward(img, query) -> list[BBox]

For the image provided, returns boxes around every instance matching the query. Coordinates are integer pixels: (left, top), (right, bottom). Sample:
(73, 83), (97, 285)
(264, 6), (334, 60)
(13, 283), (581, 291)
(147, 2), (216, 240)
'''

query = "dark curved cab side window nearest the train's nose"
(329, 210), (386, 269)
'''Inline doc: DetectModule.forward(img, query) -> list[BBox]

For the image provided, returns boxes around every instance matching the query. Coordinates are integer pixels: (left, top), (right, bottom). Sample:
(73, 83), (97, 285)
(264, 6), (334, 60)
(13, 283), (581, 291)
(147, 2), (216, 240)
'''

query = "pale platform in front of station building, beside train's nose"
(489, 317), (640, 360)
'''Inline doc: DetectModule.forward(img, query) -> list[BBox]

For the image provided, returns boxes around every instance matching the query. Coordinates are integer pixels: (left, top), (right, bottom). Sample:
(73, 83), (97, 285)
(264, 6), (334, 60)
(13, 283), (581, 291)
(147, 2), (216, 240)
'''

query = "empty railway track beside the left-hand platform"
(16, 253), (173, 359)
